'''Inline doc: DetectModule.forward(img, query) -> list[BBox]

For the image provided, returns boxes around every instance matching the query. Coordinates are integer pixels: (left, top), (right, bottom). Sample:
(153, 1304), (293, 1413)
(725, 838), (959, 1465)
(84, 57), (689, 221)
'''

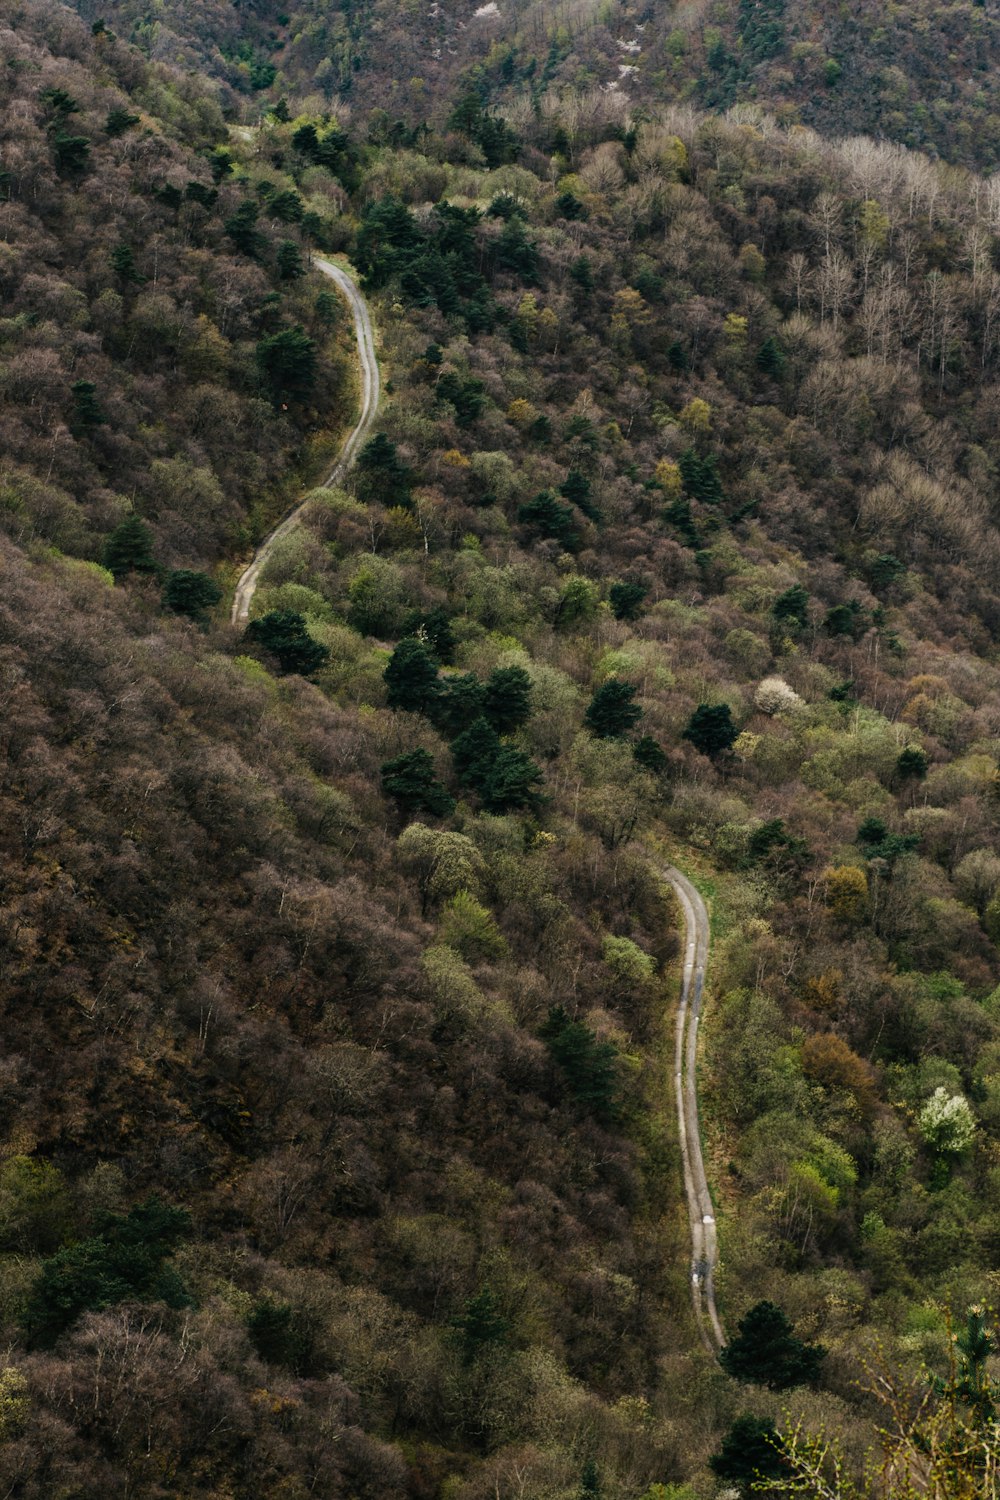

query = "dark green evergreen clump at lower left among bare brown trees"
(24, 1197), (190, 1347)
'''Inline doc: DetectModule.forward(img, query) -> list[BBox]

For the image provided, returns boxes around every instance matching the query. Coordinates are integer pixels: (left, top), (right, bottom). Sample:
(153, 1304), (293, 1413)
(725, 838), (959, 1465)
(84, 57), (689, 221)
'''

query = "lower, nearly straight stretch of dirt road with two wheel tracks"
(663, 866), (726, 1355)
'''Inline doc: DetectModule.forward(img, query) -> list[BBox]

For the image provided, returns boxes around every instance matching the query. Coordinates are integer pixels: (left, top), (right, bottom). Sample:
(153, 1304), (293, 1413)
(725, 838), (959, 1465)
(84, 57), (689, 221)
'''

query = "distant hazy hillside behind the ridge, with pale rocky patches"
(66, 0), (1000, 173)
